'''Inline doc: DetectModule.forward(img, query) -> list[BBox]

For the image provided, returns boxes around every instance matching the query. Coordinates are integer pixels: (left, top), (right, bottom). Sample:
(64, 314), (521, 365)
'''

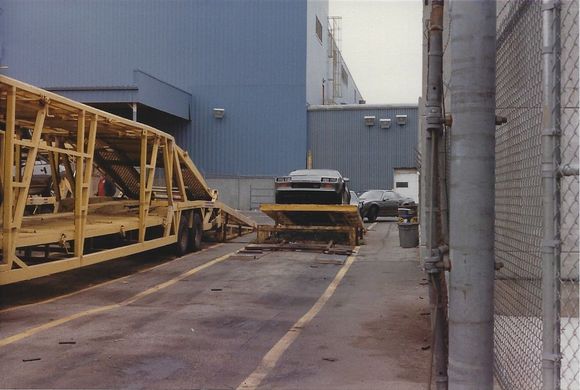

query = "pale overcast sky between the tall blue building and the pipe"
(329, 0), (423, 104)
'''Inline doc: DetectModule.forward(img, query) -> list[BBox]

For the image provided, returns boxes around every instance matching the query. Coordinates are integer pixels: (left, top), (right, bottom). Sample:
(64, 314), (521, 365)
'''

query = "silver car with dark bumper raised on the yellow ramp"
(274, 169), (350, 204)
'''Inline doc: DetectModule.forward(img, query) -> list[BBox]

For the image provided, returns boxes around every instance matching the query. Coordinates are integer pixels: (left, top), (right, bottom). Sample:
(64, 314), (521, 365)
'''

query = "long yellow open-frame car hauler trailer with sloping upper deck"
(0, 76), (255, 285)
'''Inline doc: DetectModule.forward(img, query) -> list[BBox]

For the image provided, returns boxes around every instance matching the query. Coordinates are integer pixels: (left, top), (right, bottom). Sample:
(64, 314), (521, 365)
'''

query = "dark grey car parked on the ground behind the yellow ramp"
(359, 190), (415, 222)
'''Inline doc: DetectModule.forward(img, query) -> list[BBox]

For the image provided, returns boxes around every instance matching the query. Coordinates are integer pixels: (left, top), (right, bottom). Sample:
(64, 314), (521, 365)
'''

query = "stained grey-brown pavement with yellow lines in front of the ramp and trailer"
(0, 222), (430, 390)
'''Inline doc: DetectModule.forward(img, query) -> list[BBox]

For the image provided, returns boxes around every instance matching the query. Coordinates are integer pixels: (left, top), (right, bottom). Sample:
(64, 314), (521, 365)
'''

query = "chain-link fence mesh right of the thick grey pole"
(494, 0), (580, 389)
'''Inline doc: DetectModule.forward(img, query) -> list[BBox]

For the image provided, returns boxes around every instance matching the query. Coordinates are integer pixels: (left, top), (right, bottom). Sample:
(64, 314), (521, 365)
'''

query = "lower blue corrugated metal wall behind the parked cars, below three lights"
(308, 105), (418, 191)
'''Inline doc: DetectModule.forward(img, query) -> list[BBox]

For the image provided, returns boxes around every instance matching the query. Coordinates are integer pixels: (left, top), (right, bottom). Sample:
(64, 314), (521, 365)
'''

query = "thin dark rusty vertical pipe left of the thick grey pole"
(423, 0), (448, 390)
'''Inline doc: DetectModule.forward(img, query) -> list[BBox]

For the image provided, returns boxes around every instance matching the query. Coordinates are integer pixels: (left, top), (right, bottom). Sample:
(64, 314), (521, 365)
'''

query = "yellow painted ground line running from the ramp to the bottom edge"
(237, 246), (360, 390)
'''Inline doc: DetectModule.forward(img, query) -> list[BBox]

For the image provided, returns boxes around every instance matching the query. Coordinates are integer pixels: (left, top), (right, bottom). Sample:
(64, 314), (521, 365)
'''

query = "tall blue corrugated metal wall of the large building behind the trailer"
(0, 0), (307, 175)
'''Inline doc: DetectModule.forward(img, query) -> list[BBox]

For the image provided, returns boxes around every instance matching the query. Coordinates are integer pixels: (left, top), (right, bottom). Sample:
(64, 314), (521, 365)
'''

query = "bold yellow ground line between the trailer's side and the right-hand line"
(0, 251), (237, 347)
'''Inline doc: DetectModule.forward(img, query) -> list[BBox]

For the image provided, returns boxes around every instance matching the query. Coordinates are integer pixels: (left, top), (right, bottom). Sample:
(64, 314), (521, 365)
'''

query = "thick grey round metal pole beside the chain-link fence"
(449, 0), (496, 390)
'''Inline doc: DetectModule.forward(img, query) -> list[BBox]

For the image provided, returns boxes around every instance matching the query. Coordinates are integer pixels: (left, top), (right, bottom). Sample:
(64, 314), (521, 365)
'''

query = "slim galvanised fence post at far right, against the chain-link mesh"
(542, 0), (560, 390)
